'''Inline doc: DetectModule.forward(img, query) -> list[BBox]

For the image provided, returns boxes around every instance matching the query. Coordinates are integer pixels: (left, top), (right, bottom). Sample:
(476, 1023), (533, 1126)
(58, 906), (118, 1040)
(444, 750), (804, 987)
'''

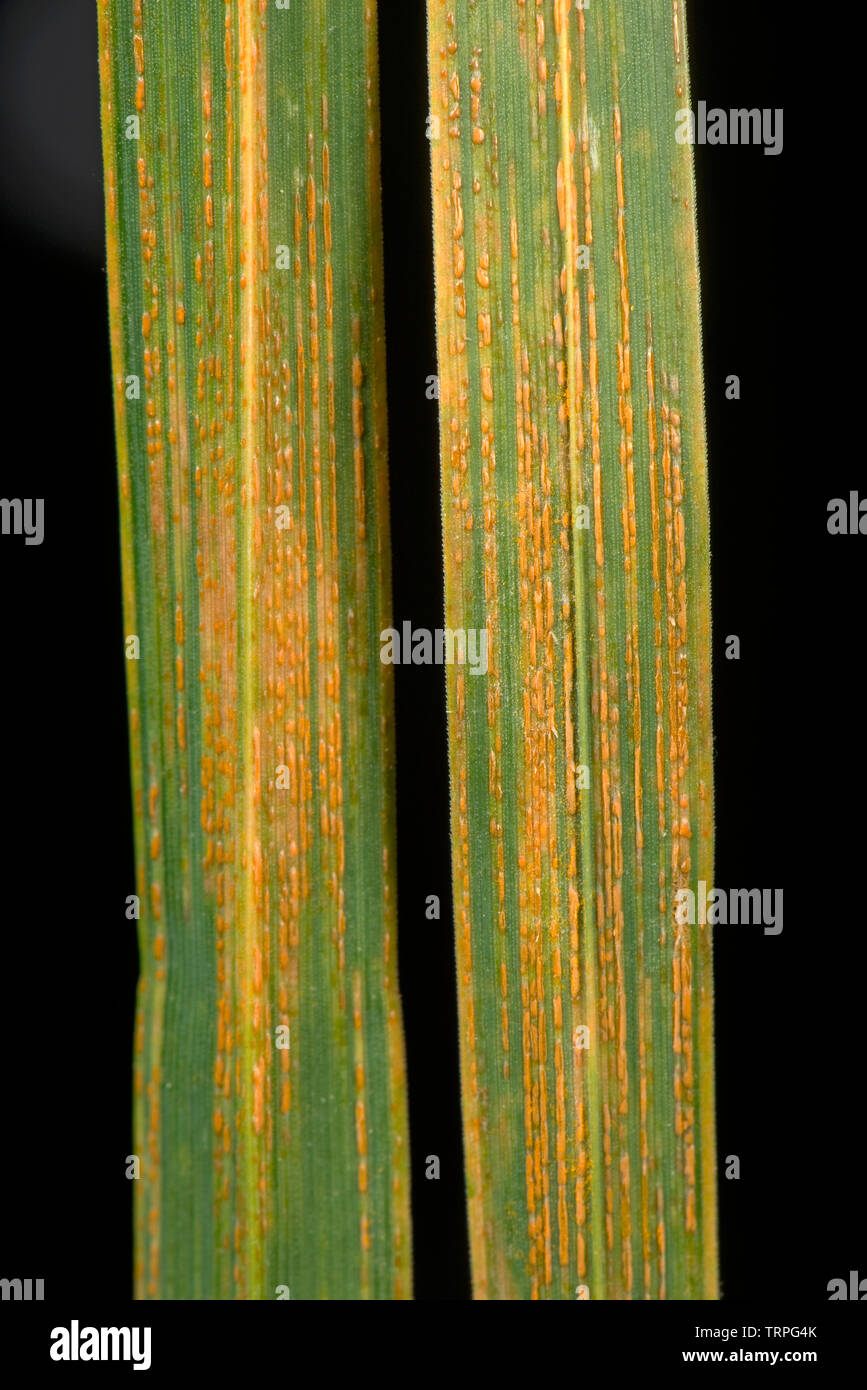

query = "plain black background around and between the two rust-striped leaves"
(0, 0), (867, 1315)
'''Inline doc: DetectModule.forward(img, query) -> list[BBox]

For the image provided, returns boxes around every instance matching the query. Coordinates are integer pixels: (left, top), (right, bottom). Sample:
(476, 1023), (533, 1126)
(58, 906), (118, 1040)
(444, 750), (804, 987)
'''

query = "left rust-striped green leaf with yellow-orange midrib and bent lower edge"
(99, 0), (410, 1298)
